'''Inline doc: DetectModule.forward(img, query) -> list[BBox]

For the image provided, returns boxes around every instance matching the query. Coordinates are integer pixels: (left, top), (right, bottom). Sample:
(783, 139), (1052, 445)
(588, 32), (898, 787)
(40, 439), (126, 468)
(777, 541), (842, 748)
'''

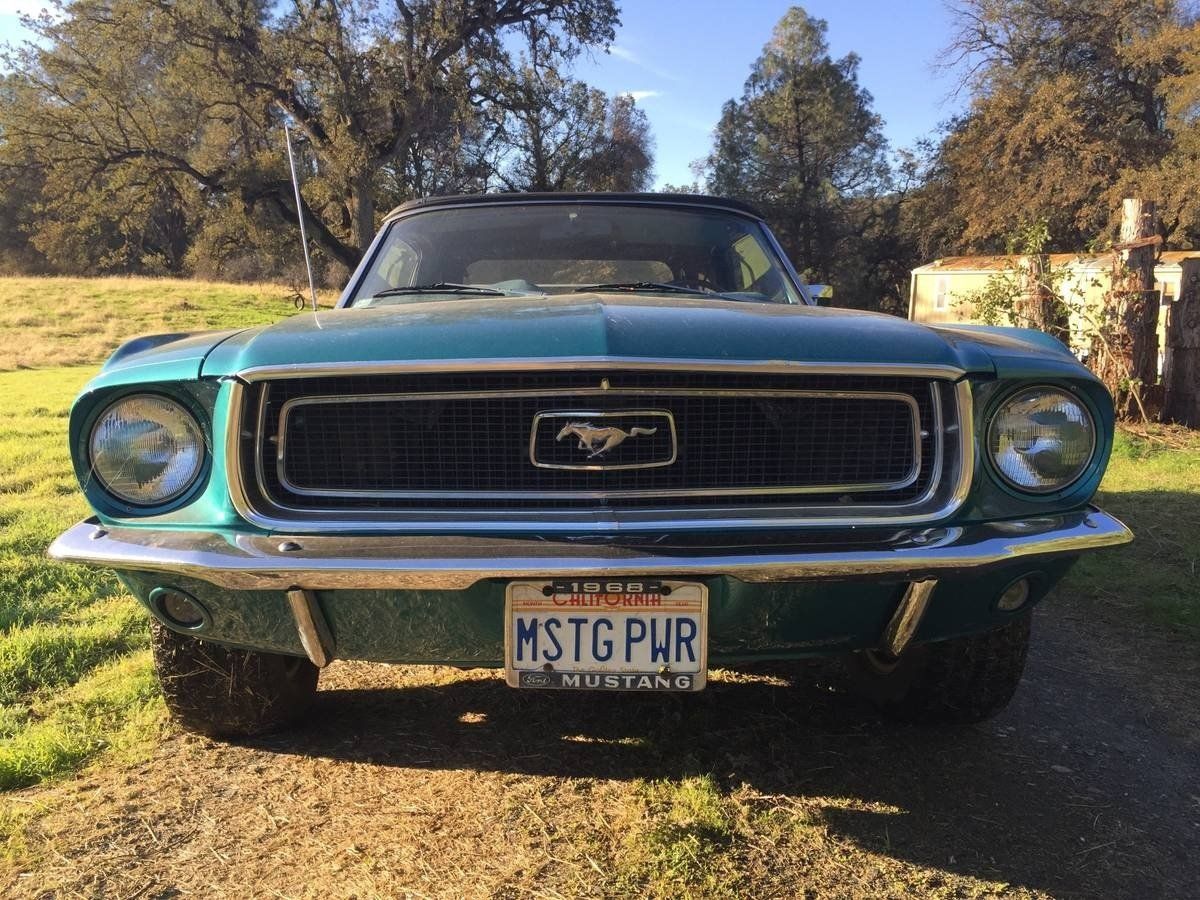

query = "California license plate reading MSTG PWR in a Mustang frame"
(504, 578), (708, 691)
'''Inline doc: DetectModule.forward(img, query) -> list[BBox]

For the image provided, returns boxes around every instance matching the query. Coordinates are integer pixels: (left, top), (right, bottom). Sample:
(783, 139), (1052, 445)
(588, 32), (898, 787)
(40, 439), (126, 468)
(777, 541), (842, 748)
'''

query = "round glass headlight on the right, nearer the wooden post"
(988, 388), (1096, 493)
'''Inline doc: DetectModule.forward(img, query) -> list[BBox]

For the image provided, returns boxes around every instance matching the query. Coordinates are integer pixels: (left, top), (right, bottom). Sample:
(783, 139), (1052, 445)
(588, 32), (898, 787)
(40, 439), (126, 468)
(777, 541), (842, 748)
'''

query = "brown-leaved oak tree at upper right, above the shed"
(941, 0), (1200, 252)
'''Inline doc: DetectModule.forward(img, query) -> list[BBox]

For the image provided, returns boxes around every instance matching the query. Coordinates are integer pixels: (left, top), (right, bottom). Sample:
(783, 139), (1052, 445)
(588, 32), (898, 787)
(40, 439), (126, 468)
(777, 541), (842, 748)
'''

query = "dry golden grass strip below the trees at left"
(0, 277), (335, 371)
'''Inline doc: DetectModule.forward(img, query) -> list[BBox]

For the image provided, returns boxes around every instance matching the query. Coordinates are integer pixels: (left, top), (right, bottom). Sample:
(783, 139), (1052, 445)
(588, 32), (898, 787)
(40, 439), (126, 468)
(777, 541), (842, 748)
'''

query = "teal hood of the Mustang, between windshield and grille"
(194, 294), (1078, 377)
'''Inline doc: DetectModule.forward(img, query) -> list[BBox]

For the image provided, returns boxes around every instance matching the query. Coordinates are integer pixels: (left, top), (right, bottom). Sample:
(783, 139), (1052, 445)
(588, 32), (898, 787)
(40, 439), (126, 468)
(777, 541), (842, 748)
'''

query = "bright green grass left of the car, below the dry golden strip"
(0, 368), (162, 788)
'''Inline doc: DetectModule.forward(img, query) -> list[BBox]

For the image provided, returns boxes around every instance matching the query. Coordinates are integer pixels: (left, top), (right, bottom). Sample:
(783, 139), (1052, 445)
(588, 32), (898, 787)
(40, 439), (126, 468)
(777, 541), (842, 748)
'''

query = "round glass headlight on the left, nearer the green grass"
(88, 394), (204, 506)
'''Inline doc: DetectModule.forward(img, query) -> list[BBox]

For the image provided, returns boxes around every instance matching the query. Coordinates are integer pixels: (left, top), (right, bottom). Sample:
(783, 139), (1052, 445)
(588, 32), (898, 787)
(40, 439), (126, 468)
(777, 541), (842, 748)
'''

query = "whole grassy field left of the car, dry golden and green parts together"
(0, 278), (331, 790)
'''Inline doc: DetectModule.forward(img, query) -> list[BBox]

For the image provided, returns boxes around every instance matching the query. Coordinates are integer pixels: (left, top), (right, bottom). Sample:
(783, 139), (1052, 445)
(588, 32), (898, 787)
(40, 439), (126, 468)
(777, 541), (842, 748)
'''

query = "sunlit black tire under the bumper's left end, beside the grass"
(150, 622), (319, 738)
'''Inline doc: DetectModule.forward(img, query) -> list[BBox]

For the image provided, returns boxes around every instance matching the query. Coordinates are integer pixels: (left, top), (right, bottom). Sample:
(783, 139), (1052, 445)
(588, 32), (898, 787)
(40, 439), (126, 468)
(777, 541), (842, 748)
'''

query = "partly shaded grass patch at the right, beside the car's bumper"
(1062, 430), (1200, 638)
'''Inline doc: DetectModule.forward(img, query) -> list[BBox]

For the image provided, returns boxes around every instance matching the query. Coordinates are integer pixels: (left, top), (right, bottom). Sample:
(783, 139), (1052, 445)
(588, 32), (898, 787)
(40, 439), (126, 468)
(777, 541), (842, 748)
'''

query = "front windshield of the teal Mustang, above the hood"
(349, 202), (803, 306)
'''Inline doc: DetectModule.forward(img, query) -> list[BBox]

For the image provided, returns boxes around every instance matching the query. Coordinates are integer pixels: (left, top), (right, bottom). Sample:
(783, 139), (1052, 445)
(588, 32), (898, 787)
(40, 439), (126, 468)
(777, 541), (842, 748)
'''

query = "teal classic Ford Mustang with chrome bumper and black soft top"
(50, 194), (1132, 734)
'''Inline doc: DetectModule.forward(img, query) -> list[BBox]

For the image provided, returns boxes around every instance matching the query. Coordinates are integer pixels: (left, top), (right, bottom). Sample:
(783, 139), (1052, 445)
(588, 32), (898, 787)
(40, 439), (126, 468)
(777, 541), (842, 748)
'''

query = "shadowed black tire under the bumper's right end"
(850, 613), (1032, 725)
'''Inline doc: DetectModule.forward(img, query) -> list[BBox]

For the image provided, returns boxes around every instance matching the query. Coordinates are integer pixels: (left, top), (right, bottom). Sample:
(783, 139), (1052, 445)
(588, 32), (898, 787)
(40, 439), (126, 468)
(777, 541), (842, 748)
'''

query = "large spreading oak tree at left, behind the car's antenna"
(0, 0), (617, 273)
